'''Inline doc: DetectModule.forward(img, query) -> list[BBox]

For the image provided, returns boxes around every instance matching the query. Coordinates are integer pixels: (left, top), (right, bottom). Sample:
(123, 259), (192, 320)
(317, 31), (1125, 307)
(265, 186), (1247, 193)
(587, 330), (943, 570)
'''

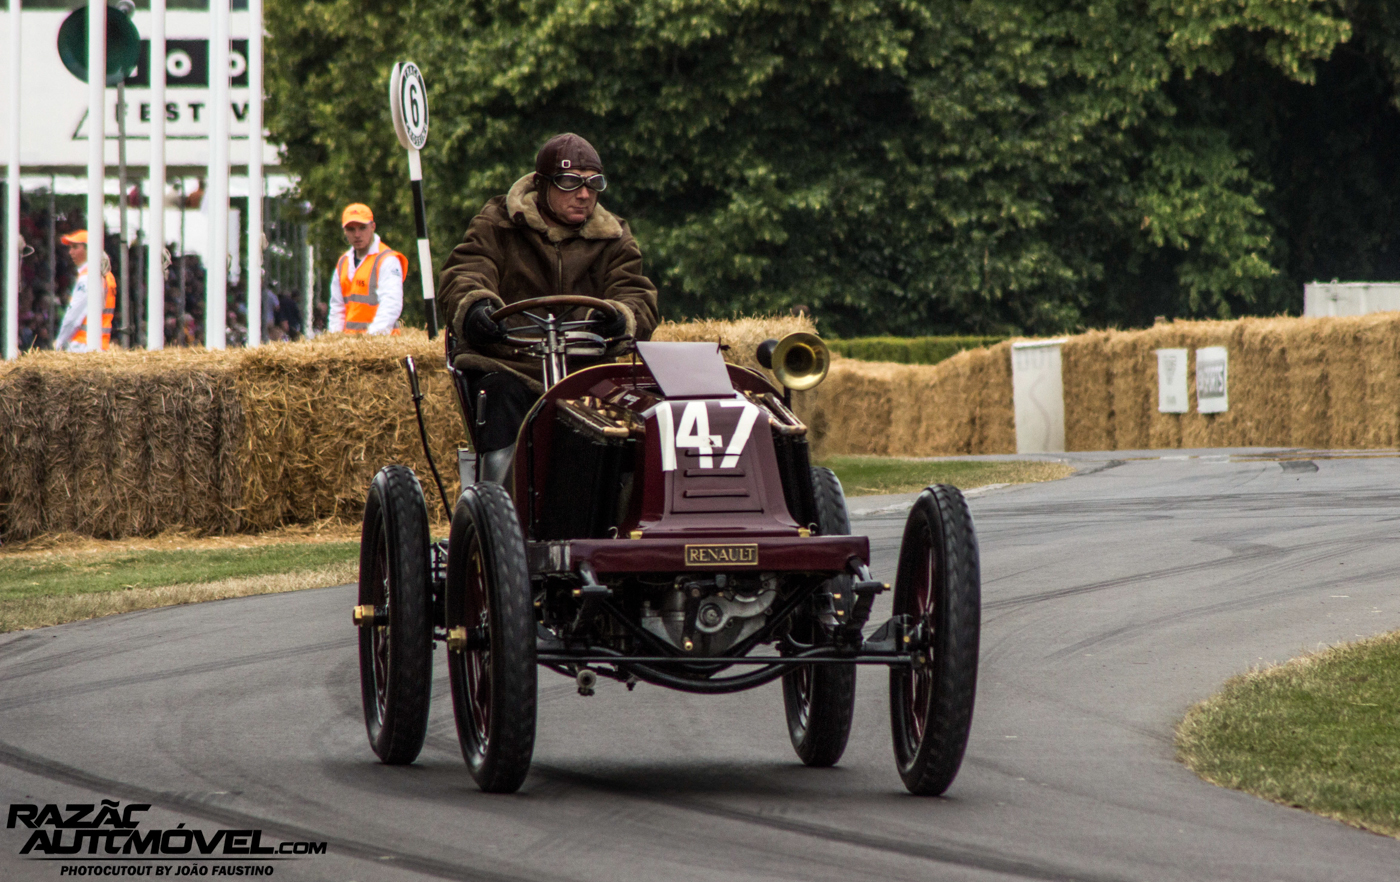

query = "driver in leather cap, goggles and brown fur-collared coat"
(438, 133), (658, 482)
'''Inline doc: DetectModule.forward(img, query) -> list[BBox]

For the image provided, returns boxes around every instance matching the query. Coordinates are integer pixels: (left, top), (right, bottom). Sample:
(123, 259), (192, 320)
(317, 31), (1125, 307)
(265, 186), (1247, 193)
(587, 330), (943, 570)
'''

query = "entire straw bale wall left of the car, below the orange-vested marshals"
(0, 332), (465, 539)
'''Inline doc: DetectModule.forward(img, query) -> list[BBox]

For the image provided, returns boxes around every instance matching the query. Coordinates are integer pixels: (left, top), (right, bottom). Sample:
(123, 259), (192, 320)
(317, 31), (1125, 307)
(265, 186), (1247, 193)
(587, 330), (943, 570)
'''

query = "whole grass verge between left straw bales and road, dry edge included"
(0, 539), (360, 633)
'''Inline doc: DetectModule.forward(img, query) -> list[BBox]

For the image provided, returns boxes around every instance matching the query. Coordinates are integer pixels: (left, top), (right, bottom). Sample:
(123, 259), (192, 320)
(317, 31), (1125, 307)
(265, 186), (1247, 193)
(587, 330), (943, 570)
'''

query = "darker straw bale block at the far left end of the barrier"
(0, 350), (242, 538)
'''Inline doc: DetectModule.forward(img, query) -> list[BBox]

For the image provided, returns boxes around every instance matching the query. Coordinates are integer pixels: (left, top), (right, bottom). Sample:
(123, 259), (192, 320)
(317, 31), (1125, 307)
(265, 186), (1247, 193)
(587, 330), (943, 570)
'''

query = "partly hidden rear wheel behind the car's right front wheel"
(783, 468), (855, 767)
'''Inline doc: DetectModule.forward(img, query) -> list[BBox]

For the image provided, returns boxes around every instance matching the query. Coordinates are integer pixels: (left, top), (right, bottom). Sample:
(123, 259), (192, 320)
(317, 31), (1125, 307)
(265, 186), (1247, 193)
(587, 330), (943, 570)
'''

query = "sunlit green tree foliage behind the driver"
(267, 0), (1400, 335)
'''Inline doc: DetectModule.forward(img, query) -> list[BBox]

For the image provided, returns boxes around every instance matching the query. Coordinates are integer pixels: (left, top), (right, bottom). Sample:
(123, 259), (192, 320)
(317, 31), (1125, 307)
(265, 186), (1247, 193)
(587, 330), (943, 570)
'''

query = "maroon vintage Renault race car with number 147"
(354, 297), (980, 794)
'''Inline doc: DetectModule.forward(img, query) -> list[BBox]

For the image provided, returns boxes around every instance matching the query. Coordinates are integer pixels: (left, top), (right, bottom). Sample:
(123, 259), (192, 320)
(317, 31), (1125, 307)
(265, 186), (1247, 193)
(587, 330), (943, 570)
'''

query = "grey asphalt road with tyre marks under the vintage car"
(0, 451), (1400, 882)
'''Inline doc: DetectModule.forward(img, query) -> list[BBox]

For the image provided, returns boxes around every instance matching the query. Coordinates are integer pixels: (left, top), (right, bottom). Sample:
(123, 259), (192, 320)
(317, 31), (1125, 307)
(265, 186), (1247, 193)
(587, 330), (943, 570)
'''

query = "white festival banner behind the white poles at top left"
(0, 10), (277, 169)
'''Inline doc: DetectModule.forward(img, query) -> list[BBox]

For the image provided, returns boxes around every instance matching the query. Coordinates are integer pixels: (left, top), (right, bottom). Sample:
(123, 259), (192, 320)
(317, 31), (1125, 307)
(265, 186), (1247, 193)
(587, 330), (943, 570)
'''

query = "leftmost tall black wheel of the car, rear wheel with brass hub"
(360, 466), (433, 766)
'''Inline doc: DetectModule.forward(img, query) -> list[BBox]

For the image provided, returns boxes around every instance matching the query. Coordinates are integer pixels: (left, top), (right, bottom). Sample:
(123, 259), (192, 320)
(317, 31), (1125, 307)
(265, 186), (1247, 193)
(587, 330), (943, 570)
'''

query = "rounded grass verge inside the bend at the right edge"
(1176, 633), (1400, 836)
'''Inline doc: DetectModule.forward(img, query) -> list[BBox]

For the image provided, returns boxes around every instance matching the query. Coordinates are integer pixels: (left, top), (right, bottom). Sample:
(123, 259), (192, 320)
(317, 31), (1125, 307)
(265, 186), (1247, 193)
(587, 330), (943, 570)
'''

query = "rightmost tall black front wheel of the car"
(889, 484), (981, 797)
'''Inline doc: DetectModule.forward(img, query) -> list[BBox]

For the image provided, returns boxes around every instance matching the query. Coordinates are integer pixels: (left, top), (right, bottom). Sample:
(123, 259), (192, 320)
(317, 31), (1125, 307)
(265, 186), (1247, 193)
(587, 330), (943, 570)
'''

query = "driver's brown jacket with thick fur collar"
(438, 174), (658, 392)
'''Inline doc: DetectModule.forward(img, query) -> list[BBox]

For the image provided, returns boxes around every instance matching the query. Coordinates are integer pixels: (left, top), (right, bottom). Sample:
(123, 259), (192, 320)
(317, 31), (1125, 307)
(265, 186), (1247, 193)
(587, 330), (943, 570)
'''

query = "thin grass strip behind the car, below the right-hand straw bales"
(818, 456), (1074, 496)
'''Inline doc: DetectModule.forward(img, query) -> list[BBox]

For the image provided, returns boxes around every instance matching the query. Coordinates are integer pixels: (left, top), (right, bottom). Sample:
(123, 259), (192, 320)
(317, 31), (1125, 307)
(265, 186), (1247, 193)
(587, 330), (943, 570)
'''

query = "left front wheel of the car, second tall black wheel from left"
(447, 482), (538, 794)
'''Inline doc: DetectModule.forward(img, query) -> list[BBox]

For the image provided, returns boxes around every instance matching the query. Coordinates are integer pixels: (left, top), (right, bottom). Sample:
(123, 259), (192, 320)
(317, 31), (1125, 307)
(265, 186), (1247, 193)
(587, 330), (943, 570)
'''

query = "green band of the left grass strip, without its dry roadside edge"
(0, 542), (360, 601)
